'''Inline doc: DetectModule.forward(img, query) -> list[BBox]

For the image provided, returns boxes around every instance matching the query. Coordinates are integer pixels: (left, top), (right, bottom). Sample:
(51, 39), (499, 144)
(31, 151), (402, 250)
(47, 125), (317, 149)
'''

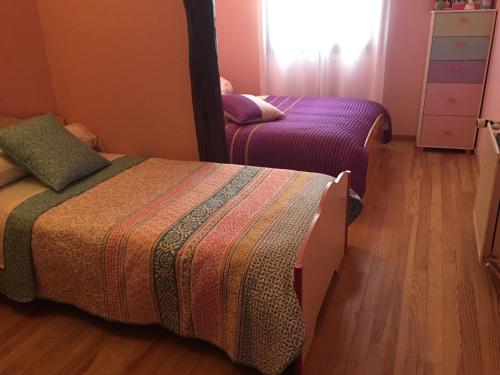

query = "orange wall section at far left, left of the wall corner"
(0, 0), (56, 117)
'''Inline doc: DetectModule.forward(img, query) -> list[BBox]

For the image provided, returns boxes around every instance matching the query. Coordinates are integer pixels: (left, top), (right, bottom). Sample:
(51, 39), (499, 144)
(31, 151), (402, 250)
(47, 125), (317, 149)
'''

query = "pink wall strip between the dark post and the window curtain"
(215, 0), (260, 94)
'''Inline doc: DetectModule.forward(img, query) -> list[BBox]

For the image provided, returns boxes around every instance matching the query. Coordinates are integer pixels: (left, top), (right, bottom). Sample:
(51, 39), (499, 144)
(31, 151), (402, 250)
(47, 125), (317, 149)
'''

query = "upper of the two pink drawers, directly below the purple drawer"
(424, 83), (483, 117)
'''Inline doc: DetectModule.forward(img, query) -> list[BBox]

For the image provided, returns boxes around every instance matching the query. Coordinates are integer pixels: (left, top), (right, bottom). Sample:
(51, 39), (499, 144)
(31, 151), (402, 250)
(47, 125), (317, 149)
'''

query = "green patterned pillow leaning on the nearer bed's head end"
(0, 114), (111, 191)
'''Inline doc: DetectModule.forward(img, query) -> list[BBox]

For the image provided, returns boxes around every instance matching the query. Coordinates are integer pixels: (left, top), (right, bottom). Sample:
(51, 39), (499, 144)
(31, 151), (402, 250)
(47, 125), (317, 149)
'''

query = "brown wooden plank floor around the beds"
(0, 142), (500, 375)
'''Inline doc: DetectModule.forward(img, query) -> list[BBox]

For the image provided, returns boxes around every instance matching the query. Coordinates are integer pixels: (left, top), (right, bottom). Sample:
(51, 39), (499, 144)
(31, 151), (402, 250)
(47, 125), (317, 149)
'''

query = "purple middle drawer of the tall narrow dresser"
(427, 60), (486, 83)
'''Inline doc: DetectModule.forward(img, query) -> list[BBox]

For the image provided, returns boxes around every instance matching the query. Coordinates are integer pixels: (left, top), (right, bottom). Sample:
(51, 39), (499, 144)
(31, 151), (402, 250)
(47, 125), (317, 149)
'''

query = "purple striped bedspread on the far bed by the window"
(226, 96), (392, 196)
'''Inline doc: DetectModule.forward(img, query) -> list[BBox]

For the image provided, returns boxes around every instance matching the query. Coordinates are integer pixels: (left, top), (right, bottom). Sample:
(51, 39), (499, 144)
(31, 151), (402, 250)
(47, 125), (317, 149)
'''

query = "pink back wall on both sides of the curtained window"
(216, 0), (434, 136)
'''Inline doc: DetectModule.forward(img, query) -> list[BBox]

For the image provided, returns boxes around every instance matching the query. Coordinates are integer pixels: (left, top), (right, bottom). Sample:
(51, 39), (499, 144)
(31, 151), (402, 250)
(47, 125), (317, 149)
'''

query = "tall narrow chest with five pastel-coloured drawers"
(417, 10), (496, 150)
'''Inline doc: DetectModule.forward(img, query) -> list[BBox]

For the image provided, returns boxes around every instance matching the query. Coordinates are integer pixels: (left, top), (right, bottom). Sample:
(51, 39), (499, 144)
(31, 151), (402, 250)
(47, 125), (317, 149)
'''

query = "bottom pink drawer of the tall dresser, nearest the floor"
(419, 116), (476, 149)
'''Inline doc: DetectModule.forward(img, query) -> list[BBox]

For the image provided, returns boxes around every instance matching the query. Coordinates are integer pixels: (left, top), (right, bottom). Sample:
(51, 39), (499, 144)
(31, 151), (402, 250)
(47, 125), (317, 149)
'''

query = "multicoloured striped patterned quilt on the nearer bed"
(0, 157), (336, 374)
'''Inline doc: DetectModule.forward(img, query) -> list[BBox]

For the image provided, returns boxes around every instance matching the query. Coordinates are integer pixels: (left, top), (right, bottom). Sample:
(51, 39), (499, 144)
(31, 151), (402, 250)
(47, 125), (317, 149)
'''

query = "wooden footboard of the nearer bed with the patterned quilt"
(293, 172), (350, 374)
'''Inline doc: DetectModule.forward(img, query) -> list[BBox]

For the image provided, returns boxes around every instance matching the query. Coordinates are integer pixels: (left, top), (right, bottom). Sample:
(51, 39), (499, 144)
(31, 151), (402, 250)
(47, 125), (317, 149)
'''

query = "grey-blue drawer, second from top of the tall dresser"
(431, 36), (490, 60)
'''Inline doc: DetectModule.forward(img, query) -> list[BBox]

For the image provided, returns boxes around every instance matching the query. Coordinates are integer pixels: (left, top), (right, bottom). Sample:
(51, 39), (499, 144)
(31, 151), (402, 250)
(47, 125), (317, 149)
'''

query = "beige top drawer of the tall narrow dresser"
(433, 11), (495, 36)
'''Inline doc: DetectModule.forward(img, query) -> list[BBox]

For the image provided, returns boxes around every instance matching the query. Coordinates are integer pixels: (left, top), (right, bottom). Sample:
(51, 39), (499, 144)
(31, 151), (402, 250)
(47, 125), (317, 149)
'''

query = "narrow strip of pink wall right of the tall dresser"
(482, 17), (500, 121)
